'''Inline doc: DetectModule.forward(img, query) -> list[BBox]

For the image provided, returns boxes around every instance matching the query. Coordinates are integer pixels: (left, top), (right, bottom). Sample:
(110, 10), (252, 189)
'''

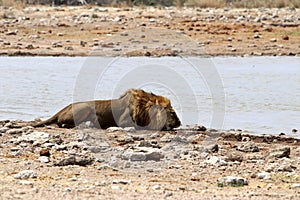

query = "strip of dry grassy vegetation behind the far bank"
(0, 0), (300, 8)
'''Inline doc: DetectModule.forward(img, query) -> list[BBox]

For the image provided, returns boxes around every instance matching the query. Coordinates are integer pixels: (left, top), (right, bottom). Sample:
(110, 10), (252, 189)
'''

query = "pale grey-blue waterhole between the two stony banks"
(0, 57), (300, 136)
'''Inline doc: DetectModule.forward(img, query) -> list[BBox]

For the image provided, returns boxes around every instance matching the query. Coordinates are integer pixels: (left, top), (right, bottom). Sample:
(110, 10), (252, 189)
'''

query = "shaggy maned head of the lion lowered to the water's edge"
(121, 89), (181, 130)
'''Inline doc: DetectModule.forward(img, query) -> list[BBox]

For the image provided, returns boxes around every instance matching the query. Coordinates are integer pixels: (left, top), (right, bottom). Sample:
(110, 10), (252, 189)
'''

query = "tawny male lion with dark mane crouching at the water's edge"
(34, 89), (181, 130)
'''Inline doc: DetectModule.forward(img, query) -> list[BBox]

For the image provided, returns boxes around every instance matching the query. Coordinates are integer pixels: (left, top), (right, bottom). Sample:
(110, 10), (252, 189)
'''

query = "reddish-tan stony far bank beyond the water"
(0, 6), (300, 56)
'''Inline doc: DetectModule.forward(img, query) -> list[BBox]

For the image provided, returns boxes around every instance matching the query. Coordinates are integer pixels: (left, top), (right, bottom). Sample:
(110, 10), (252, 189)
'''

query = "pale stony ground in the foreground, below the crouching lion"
(0, 121), (300, 199)
